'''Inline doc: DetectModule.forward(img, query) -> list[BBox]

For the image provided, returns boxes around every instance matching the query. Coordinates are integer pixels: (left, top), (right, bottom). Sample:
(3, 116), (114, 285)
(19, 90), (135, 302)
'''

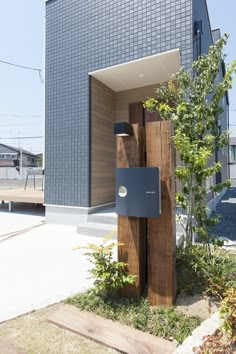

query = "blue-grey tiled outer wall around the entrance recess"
(45, 0), (193, 206)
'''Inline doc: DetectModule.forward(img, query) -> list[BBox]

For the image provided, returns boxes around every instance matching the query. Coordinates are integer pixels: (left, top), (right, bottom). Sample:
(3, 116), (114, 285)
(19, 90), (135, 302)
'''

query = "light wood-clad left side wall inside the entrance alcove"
(91, 78), (116, 206)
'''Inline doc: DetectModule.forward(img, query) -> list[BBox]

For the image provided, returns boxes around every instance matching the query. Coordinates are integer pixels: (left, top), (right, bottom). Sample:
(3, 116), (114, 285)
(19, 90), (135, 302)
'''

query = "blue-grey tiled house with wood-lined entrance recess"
(45, 0), (228, 224)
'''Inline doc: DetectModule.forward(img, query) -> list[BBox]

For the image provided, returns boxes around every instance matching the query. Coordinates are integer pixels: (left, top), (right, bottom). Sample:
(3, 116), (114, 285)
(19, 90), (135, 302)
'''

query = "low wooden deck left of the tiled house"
(0, 189), (44, 211)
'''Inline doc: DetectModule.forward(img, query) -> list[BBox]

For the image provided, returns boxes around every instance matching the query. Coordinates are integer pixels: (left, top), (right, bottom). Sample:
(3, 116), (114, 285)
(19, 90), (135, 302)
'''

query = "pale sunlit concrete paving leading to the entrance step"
(0, 212), (112, 322)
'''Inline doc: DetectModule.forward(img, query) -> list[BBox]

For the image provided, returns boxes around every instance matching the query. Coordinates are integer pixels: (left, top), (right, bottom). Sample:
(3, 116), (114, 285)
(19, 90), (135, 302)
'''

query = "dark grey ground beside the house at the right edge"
(213, 181), (236, 241)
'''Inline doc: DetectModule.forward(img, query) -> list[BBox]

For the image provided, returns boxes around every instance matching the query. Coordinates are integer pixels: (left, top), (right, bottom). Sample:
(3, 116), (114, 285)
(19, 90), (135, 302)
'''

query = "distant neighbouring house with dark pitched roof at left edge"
(0, 143), (36, 167)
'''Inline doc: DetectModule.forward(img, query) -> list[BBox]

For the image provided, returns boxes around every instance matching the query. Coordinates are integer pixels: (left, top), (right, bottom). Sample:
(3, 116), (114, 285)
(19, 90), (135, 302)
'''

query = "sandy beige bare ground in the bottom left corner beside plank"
(0, 304), (118, 354)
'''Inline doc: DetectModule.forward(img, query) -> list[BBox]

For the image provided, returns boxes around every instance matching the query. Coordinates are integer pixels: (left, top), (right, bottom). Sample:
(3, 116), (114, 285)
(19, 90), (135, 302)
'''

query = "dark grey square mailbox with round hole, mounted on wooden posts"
(116, 167), (161, 218)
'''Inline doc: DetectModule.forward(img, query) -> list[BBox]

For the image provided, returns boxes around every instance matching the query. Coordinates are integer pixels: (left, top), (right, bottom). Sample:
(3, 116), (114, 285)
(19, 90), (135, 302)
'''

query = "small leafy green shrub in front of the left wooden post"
(75, 236), (135, 296)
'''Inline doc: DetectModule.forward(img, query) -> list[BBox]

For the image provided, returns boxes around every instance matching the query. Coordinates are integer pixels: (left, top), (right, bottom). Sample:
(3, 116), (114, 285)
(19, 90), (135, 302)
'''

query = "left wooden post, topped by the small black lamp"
(117, 124), (146, 297)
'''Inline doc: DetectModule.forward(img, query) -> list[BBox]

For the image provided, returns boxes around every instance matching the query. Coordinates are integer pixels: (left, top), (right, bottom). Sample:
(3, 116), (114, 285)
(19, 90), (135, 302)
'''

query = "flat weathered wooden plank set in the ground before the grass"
(48, 305), (176, 354)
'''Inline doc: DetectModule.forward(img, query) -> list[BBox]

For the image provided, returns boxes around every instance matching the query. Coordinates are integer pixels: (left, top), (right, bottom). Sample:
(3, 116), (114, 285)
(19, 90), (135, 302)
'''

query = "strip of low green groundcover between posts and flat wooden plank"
(66, 291), (201, 343)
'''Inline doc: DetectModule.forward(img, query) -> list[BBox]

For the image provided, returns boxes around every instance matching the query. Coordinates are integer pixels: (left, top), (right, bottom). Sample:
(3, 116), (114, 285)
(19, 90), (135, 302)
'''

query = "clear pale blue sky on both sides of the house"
(0, 0), (236, 153)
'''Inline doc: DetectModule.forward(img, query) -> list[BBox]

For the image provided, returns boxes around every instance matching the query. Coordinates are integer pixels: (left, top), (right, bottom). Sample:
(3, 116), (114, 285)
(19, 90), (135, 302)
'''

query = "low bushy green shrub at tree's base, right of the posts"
(176, 245), (236, 299)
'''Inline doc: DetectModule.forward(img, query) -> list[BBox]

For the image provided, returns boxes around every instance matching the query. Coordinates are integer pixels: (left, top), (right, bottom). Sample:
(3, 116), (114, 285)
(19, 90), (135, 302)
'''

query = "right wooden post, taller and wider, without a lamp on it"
(146, 121), (176, 306)
